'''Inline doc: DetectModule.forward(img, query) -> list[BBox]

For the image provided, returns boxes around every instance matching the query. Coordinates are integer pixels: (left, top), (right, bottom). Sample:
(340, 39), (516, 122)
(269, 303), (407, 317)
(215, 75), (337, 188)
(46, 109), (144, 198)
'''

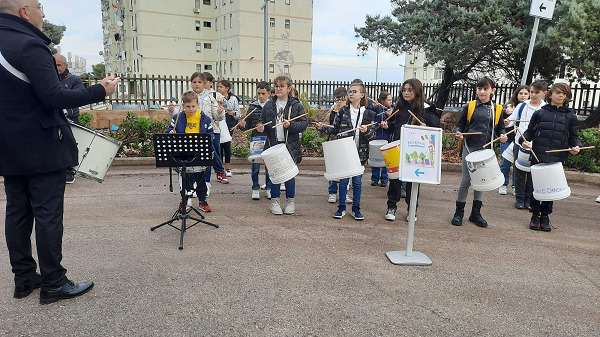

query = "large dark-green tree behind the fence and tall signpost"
(355, 0), (600, 106)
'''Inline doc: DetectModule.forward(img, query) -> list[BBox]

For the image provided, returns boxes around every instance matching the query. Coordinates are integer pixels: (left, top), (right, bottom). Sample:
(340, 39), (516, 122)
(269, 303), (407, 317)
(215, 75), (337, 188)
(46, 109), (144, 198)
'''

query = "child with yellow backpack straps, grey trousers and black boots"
(451, 76), (508, 228)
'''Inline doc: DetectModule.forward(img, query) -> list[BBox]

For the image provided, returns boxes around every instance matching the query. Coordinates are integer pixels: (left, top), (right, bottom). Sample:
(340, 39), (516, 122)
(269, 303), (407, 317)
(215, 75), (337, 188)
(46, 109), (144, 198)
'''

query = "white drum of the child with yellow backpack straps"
(465, 149), (504, 192)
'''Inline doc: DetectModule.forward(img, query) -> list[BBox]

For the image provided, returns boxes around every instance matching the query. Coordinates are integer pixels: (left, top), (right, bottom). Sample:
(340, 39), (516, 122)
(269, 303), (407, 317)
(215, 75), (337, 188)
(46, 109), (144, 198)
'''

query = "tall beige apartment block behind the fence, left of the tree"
(101, 0), (313, 80)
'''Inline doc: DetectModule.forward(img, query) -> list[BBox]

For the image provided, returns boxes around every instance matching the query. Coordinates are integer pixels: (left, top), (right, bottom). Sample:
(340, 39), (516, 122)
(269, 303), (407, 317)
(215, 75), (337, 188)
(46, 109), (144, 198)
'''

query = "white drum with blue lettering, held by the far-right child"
(531, 163), (571, 201)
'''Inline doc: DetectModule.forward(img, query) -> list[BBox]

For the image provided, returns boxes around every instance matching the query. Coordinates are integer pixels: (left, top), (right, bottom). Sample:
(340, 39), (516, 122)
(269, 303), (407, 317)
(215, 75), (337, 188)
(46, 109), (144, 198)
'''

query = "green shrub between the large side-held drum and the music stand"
(109, 111), (170, 157)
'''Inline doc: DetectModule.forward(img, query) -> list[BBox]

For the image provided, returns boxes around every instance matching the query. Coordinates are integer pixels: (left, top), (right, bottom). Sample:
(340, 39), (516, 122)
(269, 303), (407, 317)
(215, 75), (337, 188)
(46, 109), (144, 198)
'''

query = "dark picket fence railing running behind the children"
(84, 75), (600, 114)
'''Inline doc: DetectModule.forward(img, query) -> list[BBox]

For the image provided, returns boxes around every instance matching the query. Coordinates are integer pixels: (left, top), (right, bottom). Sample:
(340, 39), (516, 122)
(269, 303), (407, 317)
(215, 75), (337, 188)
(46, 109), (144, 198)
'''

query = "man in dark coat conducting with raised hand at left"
(0, 0), (118, 304)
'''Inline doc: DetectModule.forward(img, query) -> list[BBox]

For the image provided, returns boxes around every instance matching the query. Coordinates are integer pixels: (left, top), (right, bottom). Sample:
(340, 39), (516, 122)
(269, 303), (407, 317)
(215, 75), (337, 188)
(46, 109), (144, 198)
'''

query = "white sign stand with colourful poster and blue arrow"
(386, 125), (442, 266)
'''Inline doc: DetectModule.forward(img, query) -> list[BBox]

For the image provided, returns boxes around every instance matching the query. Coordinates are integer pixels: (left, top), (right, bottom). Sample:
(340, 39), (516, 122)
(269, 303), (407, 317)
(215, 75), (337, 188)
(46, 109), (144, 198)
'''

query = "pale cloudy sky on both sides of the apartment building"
(40, 0), (404, 83)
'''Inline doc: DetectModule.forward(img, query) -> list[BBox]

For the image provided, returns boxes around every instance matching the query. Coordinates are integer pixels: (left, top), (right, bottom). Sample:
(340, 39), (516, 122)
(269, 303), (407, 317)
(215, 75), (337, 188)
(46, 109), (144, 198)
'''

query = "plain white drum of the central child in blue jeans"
(324, 137), (365, 180)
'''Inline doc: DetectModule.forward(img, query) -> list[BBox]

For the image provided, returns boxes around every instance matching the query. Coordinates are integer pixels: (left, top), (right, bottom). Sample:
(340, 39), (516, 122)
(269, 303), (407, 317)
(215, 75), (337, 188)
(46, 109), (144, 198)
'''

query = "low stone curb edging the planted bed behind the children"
(113, 157), (600, 186)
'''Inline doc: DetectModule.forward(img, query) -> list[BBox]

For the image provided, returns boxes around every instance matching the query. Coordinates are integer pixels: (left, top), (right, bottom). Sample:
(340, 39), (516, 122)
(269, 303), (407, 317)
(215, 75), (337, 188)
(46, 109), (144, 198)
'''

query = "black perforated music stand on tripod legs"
(150, 133), (219, 249)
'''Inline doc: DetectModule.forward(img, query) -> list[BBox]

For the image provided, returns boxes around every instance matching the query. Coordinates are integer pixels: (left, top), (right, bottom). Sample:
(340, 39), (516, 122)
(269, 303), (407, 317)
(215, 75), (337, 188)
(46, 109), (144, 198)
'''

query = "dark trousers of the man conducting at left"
(4, 170), (67, 290)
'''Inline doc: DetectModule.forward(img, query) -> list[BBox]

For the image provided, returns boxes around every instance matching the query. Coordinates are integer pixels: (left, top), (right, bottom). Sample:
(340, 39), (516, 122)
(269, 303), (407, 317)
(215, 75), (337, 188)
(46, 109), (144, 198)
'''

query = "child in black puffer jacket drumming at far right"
(519, 83), (582, 232)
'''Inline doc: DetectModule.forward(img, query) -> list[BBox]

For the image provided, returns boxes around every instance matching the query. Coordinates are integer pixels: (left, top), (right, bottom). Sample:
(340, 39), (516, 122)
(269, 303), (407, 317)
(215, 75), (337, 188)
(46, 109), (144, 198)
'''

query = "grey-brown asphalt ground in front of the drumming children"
(0, 165), (600, 336)
